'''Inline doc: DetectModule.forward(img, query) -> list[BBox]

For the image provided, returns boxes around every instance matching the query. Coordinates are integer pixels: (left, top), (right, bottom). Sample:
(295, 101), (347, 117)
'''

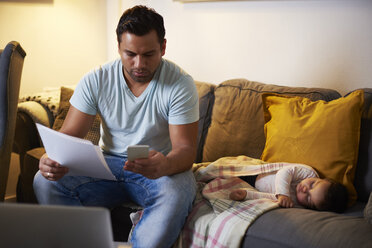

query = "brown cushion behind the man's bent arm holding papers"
(53, 87), (101, 145)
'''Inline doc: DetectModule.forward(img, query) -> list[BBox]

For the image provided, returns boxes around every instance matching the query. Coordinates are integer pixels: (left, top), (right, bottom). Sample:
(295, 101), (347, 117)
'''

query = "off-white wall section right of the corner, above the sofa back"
(117, 0), (372, 94)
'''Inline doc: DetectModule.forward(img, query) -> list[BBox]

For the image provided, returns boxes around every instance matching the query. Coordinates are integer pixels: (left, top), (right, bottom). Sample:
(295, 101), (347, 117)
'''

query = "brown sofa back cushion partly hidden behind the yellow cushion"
(202, 79), (340, 162)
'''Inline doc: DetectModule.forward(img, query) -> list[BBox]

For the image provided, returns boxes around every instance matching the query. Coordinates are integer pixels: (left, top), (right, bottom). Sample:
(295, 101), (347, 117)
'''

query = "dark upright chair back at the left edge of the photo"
(0, 41), (26, 201)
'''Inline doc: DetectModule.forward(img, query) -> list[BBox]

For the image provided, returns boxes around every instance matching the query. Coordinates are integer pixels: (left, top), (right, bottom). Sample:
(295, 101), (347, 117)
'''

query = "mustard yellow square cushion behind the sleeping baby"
(261, 90), (364, 204)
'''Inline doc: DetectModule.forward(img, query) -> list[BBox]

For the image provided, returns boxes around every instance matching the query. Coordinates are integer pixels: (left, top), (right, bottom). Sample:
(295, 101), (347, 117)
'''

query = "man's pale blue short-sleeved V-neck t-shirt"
(70, 59), (199, 156)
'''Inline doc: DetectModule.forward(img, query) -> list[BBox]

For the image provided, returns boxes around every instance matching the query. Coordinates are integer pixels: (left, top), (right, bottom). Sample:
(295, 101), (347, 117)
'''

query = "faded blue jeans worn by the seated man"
(34, 155), (196, 248)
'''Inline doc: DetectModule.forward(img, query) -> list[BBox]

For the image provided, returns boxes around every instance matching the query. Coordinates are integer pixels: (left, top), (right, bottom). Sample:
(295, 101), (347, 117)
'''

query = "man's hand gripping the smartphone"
(124, 150), (169, 179)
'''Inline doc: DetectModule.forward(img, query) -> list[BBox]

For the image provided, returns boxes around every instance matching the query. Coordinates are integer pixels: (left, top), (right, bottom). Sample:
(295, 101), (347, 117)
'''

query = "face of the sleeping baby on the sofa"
(296, 178), (331, 209)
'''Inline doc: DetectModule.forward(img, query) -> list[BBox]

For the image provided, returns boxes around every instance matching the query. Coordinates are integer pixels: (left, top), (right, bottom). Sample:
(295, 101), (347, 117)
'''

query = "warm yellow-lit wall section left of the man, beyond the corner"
(0, 0), (107, 95)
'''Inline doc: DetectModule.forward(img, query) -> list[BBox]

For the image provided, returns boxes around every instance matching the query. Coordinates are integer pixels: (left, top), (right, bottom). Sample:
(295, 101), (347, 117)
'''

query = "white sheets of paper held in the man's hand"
(36, 123), (116, 181)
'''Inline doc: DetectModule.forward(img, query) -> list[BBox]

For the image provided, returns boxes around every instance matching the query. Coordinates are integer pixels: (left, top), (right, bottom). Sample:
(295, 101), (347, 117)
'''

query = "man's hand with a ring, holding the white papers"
(39, 153), (68, 181)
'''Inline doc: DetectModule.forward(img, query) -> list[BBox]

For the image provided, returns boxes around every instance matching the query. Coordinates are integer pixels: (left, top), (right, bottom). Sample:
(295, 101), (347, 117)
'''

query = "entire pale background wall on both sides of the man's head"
(0, 0), (372, 94)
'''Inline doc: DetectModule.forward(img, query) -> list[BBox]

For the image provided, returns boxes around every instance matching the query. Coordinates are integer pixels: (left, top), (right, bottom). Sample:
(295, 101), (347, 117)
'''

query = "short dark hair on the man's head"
(116, 5), (165, 44)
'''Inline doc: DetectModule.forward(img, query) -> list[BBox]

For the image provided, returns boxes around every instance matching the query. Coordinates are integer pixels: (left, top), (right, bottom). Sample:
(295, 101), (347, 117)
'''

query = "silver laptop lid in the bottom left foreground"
(0, 203), (131, 248)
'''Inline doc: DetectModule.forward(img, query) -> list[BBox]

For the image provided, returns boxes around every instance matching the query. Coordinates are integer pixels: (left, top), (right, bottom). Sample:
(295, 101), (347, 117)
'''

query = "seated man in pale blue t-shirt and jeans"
(34, 6), (199, 247)
